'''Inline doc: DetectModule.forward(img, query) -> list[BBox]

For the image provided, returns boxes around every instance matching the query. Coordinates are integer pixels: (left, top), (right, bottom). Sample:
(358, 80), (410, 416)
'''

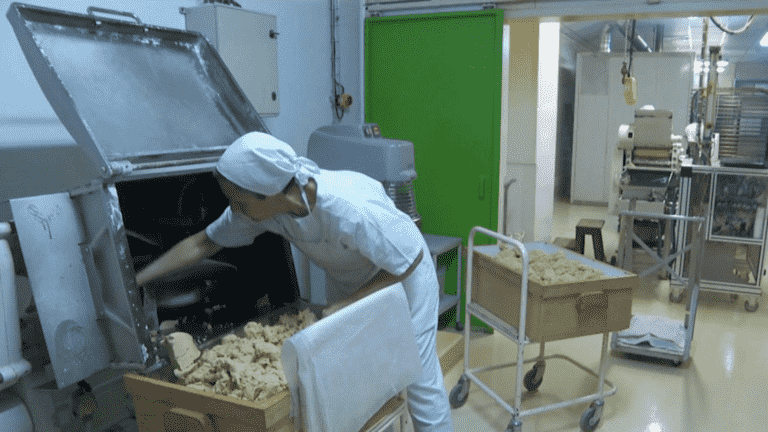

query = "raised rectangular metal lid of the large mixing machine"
(7, 3), (268, 181)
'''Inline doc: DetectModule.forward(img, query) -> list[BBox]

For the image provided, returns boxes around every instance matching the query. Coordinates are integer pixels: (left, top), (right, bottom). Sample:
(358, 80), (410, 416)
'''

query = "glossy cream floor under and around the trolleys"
(445, 203), (768, 432)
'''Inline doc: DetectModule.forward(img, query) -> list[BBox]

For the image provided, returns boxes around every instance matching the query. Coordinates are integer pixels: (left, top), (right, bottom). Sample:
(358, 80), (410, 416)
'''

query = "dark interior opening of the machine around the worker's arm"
(116, 173), (299, 342)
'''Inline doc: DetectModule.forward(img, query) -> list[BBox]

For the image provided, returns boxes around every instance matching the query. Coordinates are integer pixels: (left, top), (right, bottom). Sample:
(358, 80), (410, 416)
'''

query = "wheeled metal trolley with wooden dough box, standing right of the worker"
(449, 227), (637, 432)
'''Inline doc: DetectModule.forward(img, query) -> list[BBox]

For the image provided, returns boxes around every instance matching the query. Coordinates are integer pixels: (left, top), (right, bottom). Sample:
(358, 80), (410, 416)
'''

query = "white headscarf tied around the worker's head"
(216, 132), (320, 210)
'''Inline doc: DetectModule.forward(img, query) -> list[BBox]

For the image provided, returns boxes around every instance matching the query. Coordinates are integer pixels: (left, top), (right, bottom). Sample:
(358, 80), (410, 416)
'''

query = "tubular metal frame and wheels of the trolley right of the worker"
(449, 227), (616, 432)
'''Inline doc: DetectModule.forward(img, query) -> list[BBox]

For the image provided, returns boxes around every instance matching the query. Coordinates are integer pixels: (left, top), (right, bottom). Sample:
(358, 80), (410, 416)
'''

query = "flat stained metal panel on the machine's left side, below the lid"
(11, 193), (109, 388)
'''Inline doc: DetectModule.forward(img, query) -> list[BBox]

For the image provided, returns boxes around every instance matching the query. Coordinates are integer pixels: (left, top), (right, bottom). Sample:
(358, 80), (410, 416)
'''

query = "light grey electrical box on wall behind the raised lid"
(179, 3), (280, 117)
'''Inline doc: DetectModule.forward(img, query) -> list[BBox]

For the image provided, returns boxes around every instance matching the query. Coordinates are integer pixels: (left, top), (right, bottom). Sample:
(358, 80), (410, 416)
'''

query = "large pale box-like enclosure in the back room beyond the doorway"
(571, 52), (693, 204)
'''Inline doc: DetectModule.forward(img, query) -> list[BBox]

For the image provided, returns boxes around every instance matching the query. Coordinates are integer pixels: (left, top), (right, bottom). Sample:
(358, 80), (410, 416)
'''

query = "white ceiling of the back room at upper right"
(562, 15), (768, 63)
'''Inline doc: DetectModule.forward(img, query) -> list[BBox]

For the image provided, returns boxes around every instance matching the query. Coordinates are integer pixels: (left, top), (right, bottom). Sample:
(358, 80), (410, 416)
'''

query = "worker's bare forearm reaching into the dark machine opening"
(136, 230), (223, 286)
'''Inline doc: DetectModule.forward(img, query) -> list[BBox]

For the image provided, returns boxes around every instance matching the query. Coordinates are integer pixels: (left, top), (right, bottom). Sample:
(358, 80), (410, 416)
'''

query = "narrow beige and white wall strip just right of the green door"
(502, 18), (560, 241)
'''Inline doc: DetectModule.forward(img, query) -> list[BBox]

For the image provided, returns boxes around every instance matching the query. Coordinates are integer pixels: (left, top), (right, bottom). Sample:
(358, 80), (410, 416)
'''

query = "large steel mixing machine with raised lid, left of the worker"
(0, 3), (298, 431)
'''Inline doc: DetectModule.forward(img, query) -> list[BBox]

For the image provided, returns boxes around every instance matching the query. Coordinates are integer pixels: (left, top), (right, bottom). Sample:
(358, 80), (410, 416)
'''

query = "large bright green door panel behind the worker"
(365, 10), (504, 330)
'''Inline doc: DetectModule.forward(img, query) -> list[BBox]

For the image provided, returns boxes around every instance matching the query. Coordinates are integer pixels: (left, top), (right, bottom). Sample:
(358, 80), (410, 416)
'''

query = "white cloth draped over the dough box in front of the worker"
(282, 284), (422, 432)
